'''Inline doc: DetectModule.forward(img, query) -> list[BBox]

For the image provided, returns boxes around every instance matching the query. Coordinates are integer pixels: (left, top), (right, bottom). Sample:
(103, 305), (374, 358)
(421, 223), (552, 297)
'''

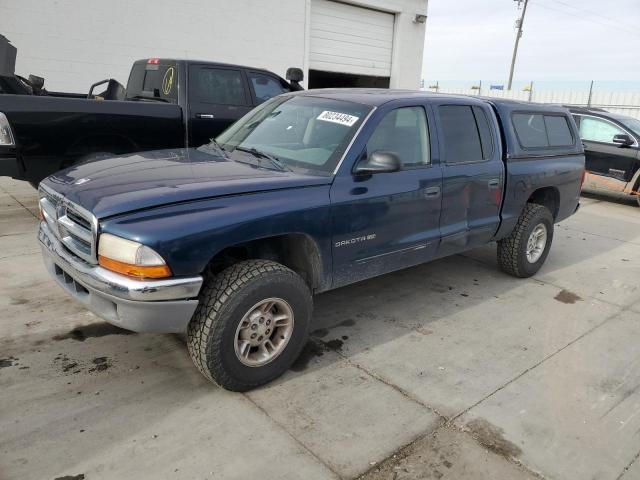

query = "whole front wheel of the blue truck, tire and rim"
(187, 260), (313, 392)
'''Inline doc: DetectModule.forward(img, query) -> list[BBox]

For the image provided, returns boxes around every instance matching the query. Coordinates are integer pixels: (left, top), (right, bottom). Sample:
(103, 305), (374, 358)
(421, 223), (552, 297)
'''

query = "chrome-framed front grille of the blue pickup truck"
(40, 186), (97, 264)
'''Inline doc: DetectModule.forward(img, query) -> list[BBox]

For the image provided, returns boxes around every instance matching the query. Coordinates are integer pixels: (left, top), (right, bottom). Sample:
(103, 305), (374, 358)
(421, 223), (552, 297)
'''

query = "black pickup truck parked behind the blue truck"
(0, 58), (303, 186)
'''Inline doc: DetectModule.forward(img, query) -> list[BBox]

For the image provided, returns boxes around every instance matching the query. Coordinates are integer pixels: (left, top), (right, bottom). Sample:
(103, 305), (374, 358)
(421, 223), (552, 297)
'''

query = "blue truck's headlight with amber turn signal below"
(98, 233), (171, 280)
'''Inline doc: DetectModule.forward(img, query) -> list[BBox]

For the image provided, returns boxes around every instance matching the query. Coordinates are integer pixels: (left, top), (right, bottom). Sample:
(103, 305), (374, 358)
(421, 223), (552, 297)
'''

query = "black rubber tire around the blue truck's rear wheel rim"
(498, 203), (553, 278)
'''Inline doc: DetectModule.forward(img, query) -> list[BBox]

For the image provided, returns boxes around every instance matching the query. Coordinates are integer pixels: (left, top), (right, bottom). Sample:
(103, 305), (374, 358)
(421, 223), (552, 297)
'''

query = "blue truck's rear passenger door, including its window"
(434, 101), (504, 256)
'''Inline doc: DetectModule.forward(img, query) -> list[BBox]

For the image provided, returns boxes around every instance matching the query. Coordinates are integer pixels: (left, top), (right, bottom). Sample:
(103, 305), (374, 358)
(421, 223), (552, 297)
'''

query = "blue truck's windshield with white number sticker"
(216, 96), (371, 173)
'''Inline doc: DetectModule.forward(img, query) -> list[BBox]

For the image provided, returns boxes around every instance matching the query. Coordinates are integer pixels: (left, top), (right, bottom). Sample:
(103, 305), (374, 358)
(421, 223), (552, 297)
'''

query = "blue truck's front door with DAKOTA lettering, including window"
(331, 105), (442, 286)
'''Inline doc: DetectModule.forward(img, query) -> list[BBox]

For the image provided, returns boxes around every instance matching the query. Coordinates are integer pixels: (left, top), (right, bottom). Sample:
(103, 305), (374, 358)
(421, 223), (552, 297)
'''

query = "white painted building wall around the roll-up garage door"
(0, 0), (427, 92)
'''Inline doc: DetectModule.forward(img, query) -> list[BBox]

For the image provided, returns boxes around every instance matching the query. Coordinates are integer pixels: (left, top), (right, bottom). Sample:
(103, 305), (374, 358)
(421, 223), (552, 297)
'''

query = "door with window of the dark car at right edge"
(575, 115), (638, 188)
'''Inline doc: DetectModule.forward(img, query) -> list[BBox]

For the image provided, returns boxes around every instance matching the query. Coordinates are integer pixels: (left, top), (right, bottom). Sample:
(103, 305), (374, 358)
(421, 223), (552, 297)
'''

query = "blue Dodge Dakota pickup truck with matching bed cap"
(39, 89), (584, 391)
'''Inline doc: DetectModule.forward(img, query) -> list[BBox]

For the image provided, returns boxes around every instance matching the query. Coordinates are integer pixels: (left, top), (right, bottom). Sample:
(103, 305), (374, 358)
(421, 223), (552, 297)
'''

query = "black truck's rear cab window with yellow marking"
(126, 63), (178, 103)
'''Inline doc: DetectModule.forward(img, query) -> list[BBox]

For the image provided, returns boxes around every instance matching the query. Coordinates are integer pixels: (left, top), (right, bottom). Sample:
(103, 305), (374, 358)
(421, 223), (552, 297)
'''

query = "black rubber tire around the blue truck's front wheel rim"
(187, 260), (313, 392)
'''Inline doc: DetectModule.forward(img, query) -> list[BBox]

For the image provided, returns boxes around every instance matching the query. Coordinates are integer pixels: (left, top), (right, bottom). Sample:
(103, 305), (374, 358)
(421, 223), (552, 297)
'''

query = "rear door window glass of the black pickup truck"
(190, 67), (246, 105)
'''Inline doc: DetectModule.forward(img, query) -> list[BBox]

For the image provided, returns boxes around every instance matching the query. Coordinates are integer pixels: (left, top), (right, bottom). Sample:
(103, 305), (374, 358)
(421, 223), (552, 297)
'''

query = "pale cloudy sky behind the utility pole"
(423, 0), (640, 90)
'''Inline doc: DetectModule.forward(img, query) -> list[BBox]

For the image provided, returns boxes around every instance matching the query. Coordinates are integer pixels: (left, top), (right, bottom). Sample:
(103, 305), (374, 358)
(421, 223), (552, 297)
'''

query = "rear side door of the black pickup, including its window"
(188, 65), (252, 147)
